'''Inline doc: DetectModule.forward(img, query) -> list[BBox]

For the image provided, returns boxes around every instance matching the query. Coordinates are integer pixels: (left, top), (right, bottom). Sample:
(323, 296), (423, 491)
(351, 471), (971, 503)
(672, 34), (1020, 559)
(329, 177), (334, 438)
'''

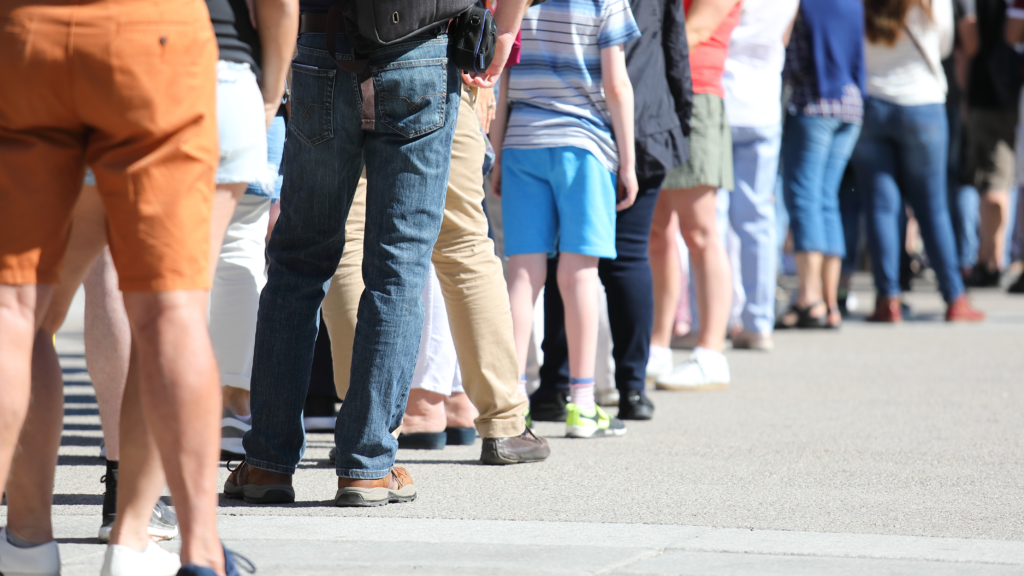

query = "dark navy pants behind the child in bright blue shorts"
(531, 176), (665, 400)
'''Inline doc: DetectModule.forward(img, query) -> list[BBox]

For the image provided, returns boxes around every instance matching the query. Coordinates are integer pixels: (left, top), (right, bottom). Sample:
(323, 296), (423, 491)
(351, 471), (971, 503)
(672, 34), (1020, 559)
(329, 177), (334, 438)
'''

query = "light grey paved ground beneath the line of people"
(0, 279), (1024, 576)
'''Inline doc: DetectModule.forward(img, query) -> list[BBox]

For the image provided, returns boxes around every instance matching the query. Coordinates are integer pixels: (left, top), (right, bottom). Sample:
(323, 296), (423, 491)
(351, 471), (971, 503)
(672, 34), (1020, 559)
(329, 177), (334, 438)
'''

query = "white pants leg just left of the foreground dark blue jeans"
(210, 194), (270, 390)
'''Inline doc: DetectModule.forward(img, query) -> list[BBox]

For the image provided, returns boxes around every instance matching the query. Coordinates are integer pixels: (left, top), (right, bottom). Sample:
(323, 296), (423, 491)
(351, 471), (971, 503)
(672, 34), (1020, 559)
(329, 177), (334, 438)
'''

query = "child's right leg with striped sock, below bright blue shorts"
(558, 252), (598, 413)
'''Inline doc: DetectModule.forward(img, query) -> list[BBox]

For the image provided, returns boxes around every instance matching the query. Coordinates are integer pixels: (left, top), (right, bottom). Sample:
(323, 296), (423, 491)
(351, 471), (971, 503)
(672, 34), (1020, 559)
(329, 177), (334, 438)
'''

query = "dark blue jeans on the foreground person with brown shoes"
(244, 34), (462, 479)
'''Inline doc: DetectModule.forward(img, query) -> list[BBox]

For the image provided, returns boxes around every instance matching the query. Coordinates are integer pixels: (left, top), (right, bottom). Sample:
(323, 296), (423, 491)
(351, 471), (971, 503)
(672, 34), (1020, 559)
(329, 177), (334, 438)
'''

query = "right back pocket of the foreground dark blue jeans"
(373, 58), (449, 138)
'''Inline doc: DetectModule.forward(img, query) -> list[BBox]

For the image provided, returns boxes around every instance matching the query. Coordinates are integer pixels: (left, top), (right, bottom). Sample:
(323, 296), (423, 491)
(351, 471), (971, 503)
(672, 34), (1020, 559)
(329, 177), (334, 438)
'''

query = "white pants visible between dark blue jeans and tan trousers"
(412, 263), (466, 396)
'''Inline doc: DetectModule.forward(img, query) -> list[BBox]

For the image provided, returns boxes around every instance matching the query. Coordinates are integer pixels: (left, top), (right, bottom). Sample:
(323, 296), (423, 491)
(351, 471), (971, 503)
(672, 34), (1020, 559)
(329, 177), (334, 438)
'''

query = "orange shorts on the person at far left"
(0, 0), (218, 292)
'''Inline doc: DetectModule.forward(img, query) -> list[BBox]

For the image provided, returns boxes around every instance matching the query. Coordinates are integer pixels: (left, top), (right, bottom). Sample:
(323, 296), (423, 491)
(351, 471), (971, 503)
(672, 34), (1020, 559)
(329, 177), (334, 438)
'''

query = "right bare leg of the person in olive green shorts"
(675, 187), (732, 353)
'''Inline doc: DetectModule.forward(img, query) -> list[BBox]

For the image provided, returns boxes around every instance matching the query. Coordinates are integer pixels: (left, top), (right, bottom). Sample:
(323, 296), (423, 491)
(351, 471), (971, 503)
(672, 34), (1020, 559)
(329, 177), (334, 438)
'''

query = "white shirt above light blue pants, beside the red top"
(722, 0), (800, 127)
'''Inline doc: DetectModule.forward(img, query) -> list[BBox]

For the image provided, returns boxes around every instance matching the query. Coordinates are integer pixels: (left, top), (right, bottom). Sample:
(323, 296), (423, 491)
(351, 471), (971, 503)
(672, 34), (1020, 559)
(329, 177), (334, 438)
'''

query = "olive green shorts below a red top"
(662, 94), (733, 190)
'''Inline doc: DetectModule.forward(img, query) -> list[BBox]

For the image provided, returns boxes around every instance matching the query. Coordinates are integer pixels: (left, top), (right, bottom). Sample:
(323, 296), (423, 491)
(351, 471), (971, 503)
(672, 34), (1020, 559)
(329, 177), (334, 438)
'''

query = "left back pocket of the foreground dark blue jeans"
(289, 63), (338, 146)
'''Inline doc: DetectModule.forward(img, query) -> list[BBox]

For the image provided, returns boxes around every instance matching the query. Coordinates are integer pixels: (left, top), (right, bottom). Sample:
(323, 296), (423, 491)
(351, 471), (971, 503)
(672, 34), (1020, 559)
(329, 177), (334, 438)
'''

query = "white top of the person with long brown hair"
(864, 0), (953, 106)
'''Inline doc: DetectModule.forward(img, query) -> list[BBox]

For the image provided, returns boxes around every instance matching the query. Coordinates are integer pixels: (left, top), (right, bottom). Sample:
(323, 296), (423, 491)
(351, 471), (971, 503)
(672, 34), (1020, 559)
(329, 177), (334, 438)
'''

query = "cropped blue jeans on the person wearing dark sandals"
(782, 115), (860, 258)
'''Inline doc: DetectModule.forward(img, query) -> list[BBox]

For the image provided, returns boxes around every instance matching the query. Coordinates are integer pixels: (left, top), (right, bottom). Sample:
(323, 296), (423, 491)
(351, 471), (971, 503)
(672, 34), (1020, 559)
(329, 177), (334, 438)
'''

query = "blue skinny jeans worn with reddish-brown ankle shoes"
(853, 98), (964, 302)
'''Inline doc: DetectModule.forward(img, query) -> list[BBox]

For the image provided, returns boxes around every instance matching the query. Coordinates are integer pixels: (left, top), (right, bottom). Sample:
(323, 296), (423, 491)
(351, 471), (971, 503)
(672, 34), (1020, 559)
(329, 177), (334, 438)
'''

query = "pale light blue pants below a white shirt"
(719, 126), (782, 333)
